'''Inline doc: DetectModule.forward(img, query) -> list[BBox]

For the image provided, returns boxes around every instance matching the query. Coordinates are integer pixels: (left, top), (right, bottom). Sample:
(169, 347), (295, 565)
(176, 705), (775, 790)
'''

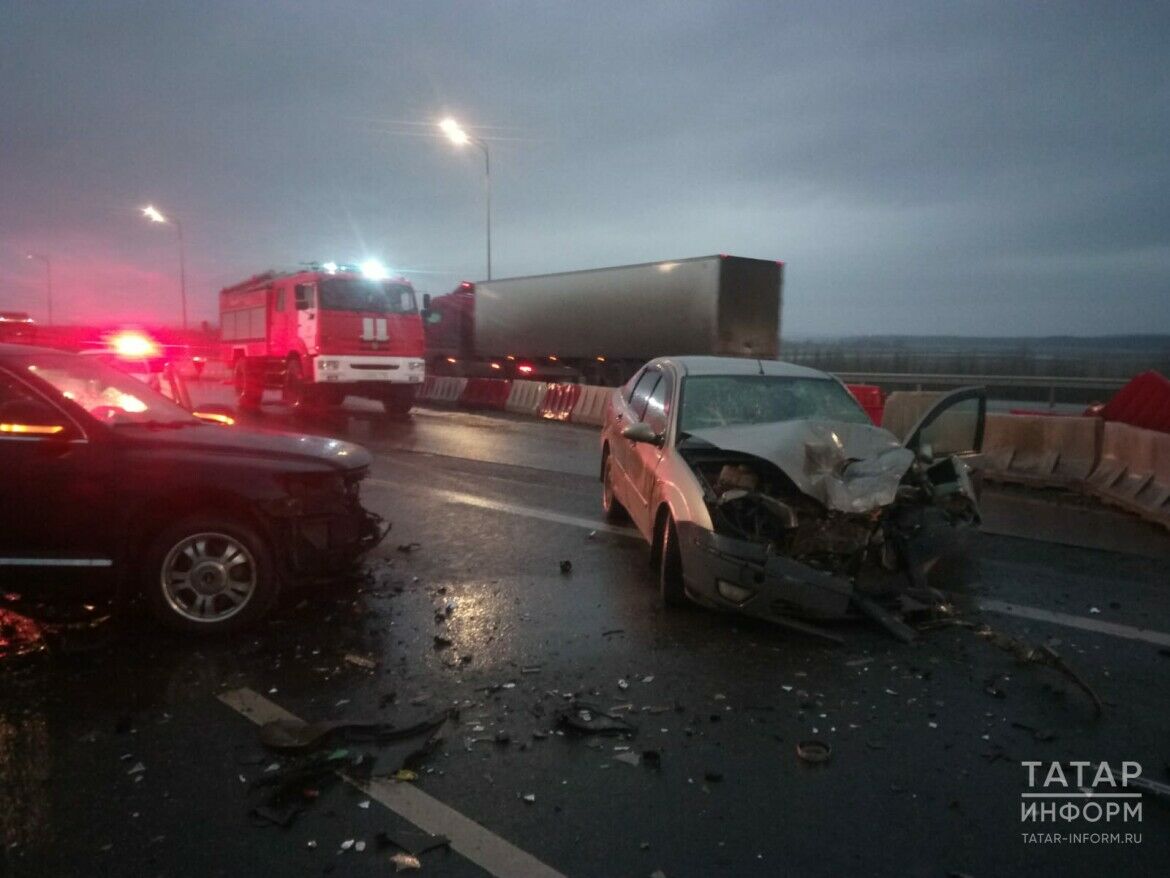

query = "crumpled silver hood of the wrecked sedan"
(690, 420), (914, 513)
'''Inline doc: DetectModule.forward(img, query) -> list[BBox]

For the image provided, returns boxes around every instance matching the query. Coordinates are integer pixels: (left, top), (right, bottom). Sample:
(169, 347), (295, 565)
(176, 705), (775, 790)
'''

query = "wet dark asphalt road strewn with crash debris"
(0, 391), (1170, 878)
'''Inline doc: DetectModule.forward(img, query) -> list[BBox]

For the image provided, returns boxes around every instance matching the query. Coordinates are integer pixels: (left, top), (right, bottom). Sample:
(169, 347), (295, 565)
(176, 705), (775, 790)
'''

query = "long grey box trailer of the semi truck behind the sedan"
(424, 255), (784, 385)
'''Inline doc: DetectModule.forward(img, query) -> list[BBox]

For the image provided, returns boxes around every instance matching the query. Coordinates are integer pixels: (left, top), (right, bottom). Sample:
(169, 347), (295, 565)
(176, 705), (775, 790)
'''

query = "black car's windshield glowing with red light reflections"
(25, 354), (200, 425)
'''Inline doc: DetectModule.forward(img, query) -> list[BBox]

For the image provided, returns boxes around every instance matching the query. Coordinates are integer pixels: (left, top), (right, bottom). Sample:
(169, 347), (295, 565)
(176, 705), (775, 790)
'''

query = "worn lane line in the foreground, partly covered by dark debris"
(219, 688), (565, 878)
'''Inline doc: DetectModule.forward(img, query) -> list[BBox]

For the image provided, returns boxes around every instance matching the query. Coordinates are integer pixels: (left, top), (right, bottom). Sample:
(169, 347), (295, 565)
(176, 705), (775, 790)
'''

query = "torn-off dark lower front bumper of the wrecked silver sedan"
(677, 521), (854, 624)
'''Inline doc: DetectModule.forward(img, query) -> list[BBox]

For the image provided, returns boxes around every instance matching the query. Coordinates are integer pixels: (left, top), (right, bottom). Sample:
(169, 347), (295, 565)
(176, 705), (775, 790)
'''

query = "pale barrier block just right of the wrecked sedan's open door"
(983, 413), (1102, 487)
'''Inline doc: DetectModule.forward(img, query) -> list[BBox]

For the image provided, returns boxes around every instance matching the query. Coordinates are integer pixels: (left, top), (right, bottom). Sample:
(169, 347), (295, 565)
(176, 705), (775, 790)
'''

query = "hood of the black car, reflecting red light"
(113, 424), (371, 472)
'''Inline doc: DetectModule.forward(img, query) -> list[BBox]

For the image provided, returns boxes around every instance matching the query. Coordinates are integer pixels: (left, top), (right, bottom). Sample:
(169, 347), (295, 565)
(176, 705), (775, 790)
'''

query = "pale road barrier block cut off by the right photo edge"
(1087, 421), (1170, 528)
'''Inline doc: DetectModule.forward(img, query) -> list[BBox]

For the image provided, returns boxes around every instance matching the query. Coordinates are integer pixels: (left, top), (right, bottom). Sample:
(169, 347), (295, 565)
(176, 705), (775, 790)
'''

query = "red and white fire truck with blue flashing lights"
(220, 262), (425, 414)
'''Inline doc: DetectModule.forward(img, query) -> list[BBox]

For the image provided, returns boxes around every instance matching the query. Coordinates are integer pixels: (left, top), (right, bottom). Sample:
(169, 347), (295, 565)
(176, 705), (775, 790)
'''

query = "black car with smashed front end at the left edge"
(0, 344), (383, 632)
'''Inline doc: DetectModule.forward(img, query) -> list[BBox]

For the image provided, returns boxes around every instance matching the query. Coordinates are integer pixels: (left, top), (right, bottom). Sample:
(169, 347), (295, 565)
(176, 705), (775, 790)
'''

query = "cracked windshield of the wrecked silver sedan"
(679, 375), (872, 433)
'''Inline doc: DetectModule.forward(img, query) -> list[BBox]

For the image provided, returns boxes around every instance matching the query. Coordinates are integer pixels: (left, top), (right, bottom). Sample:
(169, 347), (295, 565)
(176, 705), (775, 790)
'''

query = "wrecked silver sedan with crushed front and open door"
(601, 357), (986, 639)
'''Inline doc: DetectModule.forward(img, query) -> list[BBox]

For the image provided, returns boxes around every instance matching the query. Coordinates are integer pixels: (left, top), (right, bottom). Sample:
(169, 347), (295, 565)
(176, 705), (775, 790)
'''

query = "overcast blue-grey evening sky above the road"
(0, 0), (1170, 336)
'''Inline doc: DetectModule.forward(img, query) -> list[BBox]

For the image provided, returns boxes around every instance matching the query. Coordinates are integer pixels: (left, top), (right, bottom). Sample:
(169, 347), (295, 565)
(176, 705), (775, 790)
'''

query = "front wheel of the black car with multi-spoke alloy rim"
(140, 513), (280, 635)
